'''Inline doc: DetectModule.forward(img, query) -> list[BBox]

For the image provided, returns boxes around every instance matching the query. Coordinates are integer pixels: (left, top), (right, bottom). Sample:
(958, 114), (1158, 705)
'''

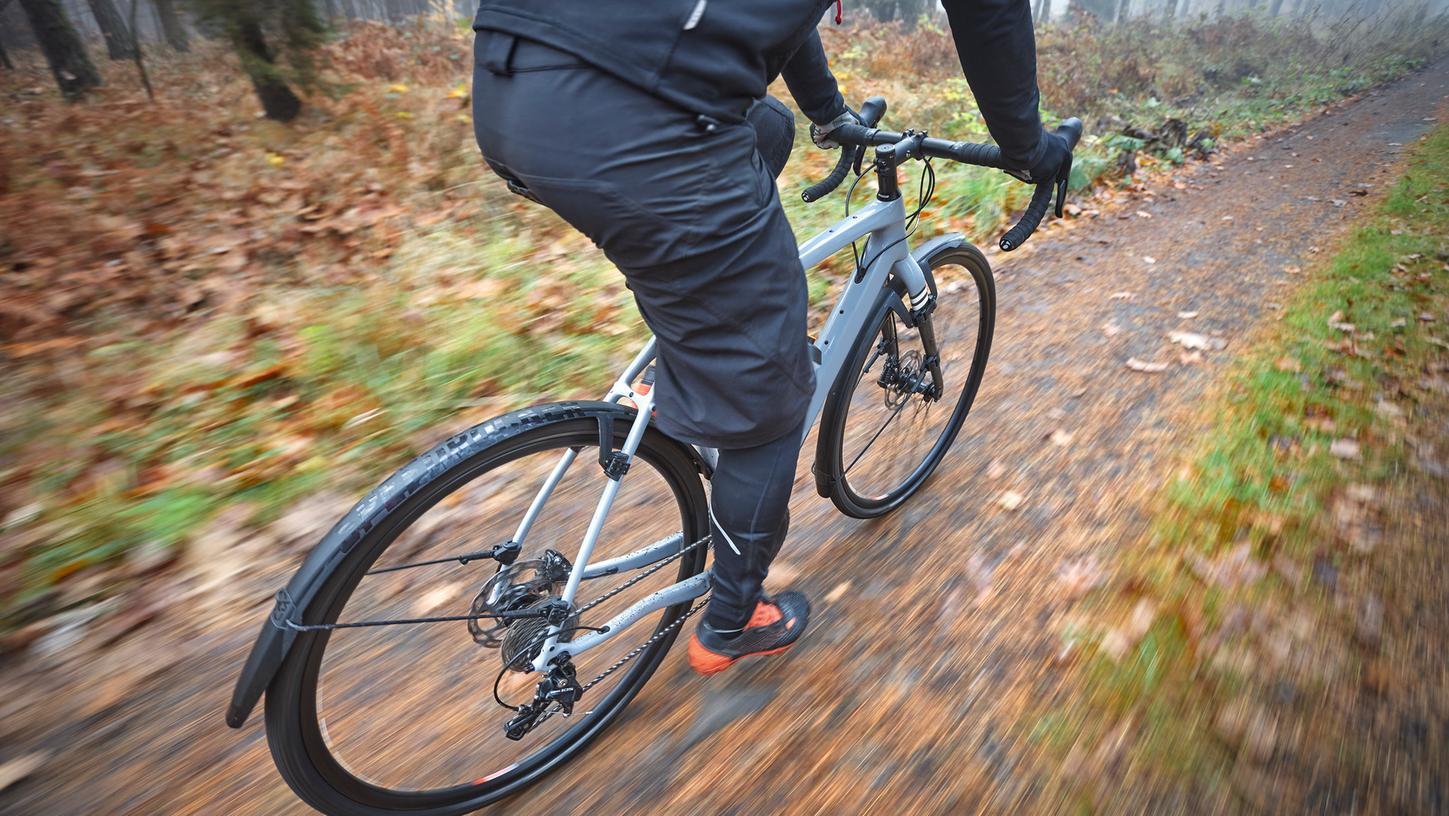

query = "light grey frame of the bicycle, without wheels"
(524, 196), (927, 671)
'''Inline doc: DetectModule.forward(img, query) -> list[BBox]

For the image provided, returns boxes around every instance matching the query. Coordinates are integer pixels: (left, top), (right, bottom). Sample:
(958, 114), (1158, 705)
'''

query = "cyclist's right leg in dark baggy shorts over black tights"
(474, 33), (814, 665)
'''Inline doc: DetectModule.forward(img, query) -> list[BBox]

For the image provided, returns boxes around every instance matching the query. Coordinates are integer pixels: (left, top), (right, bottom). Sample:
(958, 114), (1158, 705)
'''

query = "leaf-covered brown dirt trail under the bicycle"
(0, 62), (1449, 816)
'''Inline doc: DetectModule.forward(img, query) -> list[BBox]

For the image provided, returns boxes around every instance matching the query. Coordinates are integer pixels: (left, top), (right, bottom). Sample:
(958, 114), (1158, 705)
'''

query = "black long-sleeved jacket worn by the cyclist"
(472, 0), (1042, 168)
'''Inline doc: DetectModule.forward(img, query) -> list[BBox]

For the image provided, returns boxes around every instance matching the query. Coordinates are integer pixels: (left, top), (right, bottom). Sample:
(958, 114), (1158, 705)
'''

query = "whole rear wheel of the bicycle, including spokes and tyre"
(267, 409), (709, 816)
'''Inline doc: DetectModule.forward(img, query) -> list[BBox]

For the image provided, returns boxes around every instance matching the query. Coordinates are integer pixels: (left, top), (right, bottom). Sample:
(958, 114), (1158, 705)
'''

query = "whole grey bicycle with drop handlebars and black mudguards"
(226, 97), (1081, 816)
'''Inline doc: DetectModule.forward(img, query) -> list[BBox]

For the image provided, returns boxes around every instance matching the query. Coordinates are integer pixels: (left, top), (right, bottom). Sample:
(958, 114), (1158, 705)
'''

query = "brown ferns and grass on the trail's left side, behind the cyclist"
(0, 17), (1440, 628)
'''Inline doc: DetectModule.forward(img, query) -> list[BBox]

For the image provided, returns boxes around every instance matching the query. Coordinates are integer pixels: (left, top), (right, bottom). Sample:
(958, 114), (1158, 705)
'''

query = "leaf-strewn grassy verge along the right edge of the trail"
(1035, 119), (1449, 812)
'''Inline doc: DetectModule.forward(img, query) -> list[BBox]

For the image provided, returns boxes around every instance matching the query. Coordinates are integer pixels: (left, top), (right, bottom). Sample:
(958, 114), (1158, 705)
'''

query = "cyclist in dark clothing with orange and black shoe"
(472, 0), (1069, 674)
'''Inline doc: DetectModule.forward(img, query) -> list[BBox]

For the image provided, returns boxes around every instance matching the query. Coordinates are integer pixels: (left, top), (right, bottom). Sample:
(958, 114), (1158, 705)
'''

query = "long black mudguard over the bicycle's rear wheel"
(226, 400), (710, 728)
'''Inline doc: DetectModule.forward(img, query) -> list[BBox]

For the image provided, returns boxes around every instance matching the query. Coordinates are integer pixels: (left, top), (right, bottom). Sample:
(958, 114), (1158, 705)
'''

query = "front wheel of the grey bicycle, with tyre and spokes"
(814, 243), (995, 519)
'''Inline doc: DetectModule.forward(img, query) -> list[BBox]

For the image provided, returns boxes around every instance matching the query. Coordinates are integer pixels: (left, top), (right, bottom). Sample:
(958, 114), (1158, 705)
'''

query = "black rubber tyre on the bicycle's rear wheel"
(267, 406), (709, 816)
